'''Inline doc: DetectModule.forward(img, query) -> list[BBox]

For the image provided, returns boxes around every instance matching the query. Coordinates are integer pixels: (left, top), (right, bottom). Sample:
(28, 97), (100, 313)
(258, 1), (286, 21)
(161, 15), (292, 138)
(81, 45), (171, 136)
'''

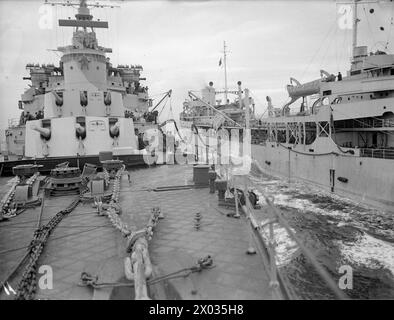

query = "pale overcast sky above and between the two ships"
(0, 0), (394, 132)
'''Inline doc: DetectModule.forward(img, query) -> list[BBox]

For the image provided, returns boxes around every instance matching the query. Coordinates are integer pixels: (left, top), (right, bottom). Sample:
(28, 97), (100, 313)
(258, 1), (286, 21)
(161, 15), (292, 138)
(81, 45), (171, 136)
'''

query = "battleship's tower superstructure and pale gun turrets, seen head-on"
(1, 0), (157, 174)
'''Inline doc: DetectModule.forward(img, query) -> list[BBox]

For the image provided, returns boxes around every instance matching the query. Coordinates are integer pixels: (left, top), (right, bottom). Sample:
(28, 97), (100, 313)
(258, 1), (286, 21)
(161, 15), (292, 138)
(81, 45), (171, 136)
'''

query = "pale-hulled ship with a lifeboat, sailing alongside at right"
(180, 1), (394, 212)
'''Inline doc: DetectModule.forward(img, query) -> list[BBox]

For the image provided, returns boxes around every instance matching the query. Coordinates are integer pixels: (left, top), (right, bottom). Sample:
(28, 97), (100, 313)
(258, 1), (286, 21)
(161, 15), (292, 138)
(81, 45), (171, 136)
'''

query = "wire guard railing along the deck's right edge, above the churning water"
(219, 163), (348, 299)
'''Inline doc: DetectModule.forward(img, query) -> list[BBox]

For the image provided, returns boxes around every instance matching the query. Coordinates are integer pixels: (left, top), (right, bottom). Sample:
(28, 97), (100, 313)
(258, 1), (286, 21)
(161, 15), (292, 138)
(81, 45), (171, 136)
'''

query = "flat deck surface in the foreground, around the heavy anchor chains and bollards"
(0, 165), (278, 299)
